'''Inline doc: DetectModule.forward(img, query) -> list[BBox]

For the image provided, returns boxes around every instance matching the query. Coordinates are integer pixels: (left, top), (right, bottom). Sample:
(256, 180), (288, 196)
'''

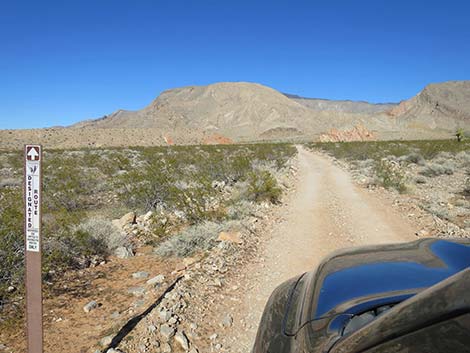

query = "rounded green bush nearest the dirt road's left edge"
(246, 170), (282, 203)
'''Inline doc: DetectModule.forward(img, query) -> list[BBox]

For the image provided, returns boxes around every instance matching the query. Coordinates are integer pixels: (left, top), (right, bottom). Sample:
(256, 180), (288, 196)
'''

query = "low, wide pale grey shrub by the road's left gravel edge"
(155, 221), (225, 257)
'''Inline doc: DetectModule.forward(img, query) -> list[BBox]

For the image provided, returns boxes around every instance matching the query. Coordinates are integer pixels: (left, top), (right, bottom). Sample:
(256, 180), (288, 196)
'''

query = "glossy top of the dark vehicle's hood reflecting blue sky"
(309, 239), (470, 320)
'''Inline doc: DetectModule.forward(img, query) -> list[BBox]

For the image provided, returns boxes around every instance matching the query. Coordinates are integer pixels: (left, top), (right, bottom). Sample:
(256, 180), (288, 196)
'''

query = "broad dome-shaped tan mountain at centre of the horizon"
(76, 82), (360, 139)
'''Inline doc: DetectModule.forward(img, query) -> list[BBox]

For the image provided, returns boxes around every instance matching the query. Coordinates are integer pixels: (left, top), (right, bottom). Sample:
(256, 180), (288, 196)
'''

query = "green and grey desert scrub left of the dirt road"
(0, 144), (296, 316)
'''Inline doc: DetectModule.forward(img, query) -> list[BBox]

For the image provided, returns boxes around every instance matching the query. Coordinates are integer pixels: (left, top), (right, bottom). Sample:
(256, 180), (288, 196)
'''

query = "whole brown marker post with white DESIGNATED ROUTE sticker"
(24, 145), (43, 353)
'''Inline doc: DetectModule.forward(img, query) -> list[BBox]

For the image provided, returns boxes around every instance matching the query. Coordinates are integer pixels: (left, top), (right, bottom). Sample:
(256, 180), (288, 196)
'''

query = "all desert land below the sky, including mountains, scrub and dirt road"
(0, 81), (470, 353)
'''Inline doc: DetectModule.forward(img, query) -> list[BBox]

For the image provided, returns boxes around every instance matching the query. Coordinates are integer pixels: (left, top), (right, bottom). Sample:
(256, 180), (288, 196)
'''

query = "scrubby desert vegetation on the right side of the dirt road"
(309, 138), (470, 232)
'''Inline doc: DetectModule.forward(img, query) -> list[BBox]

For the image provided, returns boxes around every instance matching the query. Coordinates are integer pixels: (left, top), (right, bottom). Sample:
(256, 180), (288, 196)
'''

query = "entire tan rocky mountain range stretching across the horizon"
(0, 81), (470, 148)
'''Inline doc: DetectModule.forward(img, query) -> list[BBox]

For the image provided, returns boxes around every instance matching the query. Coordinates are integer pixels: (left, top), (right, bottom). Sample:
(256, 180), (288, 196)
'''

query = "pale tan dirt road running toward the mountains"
(225, 147), (416, 353)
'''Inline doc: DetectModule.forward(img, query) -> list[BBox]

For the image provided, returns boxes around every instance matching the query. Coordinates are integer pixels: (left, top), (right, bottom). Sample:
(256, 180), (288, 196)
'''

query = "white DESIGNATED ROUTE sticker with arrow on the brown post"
(25, 146), (41, 252)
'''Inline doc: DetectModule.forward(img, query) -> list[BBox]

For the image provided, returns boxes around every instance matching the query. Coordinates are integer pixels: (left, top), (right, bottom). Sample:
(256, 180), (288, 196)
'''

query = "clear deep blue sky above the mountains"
(0, 0), (470, 129)
